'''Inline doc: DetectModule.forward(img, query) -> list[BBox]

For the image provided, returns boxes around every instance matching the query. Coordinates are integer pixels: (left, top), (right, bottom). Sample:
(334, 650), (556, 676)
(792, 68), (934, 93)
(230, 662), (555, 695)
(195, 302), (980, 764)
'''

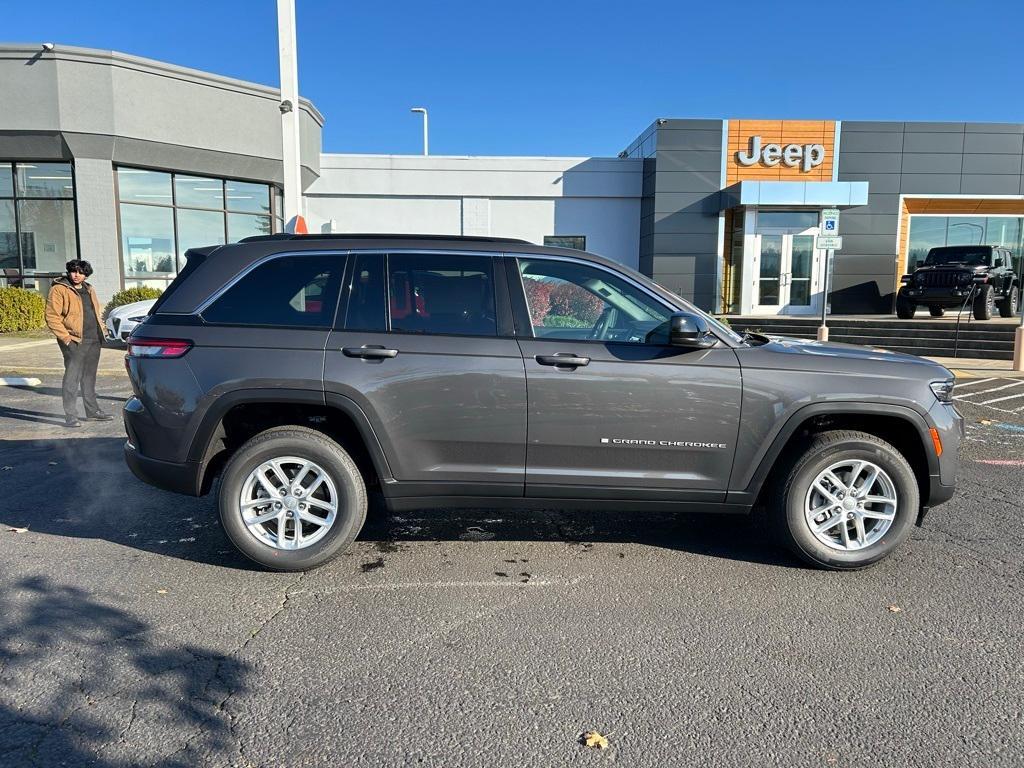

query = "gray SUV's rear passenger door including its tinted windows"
(324, 251), (526, 496)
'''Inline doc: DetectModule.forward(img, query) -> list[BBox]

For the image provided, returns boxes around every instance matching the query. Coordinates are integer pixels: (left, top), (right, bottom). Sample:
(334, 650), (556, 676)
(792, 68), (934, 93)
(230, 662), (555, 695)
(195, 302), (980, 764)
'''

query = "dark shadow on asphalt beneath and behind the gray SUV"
(0, 437), (798, 570)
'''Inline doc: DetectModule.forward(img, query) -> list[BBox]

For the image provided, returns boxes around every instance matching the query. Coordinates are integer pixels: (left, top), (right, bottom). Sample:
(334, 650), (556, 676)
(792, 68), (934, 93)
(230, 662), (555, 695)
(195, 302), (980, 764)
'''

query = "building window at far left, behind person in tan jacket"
(0, 162), (78, 291)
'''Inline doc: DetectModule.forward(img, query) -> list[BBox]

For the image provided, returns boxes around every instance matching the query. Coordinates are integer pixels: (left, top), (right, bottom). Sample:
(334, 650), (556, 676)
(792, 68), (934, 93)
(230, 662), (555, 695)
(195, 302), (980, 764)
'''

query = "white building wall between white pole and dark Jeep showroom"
(306, 155), (643, 267)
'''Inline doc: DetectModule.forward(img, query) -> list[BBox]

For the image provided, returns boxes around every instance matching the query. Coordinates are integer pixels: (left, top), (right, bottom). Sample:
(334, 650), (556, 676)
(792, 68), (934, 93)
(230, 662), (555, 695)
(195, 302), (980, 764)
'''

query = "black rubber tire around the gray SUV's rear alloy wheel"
(218, 427), (367, 570)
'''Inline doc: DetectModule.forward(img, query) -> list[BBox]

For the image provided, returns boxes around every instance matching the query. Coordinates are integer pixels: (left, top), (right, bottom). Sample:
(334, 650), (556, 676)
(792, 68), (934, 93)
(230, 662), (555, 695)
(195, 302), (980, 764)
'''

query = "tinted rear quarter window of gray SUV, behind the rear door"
(203, 256), (345, 328)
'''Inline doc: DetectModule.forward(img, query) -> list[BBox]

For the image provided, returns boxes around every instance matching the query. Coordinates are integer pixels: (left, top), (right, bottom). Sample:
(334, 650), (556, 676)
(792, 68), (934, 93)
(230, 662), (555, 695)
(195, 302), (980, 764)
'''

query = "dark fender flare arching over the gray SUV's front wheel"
(727, 400), (939, 505)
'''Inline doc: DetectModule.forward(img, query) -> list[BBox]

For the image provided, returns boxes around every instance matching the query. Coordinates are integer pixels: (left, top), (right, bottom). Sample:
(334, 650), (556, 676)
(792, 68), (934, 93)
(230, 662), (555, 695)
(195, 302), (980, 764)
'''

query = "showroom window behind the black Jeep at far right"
(906, 214), (1024, 272)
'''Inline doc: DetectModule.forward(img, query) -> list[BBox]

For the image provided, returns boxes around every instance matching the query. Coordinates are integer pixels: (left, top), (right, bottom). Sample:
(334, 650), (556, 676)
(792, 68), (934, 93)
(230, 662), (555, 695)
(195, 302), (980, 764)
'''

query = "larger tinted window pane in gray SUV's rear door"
(387, 253), (498, 336)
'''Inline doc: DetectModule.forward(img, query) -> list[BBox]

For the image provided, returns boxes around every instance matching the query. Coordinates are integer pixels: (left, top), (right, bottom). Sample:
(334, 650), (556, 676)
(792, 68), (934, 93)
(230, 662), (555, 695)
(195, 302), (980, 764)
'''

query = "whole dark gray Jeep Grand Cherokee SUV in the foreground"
(124, 234), (962, 570)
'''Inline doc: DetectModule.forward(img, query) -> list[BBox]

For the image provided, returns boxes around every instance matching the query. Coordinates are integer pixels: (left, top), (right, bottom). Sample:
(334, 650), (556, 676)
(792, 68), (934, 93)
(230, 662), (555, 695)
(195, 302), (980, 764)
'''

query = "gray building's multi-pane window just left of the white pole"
(117, 168), (283, 288)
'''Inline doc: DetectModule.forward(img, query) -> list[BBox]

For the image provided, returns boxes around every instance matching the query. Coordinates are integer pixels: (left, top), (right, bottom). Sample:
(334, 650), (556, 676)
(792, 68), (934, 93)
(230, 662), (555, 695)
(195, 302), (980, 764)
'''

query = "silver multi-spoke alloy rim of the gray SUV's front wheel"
(804, 459), (897, 551)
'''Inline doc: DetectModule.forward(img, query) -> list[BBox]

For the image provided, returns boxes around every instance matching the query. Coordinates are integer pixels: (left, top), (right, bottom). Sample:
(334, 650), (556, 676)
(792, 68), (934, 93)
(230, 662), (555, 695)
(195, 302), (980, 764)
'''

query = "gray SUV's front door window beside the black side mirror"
(519, 259), (672, 344)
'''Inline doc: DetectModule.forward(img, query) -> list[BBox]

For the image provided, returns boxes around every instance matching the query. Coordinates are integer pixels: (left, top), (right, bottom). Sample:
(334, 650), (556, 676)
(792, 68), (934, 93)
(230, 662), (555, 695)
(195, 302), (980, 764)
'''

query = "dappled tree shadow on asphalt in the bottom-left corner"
(0, 577), (247, 768)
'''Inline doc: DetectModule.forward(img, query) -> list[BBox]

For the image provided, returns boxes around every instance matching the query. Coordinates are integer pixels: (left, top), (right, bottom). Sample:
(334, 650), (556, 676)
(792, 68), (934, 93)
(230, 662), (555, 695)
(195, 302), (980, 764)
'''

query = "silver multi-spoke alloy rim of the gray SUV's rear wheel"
(239, 456), (338, 550)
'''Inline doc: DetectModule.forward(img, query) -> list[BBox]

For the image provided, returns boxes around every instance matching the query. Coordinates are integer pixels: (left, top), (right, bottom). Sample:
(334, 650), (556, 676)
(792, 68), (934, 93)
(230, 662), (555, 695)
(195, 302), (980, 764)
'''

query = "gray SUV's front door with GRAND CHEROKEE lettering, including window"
(509, 256), (740, 502)
